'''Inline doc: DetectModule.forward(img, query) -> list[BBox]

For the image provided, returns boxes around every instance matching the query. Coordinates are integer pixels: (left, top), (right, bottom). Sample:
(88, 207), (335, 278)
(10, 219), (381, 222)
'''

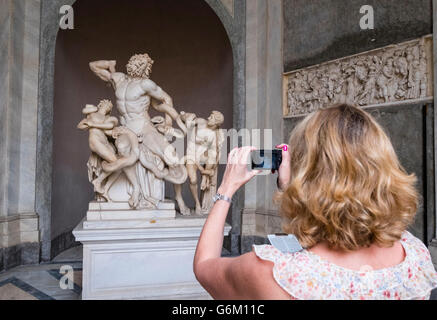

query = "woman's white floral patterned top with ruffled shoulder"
(253, 231), (437, 300)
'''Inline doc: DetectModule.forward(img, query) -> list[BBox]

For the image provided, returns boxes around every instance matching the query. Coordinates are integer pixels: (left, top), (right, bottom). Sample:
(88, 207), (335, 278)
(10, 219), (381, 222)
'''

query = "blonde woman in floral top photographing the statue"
(194, 105), (437, 300)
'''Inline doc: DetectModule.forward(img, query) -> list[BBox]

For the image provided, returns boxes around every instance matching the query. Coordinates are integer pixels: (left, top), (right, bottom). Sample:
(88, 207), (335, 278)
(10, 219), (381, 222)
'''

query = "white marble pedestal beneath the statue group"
(73, 202), (231, 300)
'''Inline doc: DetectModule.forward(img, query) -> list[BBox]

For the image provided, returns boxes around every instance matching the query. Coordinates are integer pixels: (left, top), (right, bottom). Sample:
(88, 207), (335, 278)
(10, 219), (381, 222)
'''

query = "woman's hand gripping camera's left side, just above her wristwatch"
(217, 147), (260, 198)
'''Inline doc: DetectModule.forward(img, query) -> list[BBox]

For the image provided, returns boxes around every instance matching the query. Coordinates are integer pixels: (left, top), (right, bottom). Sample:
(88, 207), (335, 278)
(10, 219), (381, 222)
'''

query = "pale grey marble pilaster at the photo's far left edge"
(0, 0), (40, 269)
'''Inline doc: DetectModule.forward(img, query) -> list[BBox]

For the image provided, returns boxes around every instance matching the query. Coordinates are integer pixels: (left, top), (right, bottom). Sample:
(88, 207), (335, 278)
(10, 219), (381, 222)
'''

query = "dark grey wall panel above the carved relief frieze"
(284, 0), (432, 72)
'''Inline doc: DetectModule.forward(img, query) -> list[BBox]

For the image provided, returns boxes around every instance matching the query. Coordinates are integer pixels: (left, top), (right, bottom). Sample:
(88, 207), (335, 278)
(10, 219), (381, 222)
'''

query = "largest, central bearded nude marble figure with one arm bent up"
(90, 54), (189, 213)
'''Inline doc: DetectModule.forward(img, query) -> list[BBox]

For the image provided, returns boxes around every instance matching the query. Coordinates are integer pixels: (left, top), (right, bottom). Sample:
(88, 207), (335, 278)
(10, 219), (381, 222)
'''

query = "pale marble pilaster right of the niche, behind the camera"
(242, 0), (284, 251)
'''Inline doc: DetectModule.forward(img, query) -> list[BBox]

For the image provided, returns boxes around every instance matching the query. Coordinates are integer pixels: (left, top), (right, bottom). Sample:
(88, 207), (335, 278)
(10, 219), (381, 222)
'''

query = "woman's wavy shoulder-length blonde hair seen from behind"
(277, 104), (418, 251)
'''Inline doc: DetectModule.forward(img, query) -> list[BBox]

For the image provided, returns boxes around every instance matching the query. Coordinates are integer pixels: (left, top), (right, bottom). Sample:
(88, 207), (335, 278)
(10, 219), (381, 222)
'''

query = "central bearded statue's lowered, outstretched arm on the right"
(141, 79), (187, 134)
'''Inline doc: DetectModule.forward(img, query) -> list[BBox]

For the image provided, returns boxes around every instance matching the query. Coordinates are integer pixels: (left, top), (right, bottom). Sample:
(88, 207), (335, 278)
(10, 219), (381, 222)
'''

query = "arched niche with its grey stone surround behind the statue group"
(36, 0), (245, 261)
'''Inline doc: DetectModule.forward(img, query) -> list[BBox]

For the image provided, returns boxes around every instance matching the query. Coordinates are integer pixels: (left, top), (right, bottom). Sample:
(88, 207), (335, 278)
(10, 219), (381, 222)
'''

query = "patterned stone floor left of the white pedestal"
(0, 247), (82, 300)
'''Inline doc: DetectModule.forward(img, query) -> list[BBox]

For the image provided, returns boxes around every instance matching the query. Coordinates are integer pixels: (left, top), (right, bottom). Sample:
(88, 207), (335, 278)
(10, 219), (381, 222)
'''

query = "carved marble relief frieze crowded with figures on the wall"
(284, 36), (432, 116)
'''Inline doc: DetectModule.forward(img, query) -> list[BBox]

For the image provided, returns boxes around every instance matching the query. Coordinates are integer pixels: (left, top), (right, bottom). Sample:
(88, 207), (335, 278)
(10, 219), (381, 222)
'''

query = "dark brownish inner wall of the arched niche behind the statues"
(51, 0), (233, 248)
